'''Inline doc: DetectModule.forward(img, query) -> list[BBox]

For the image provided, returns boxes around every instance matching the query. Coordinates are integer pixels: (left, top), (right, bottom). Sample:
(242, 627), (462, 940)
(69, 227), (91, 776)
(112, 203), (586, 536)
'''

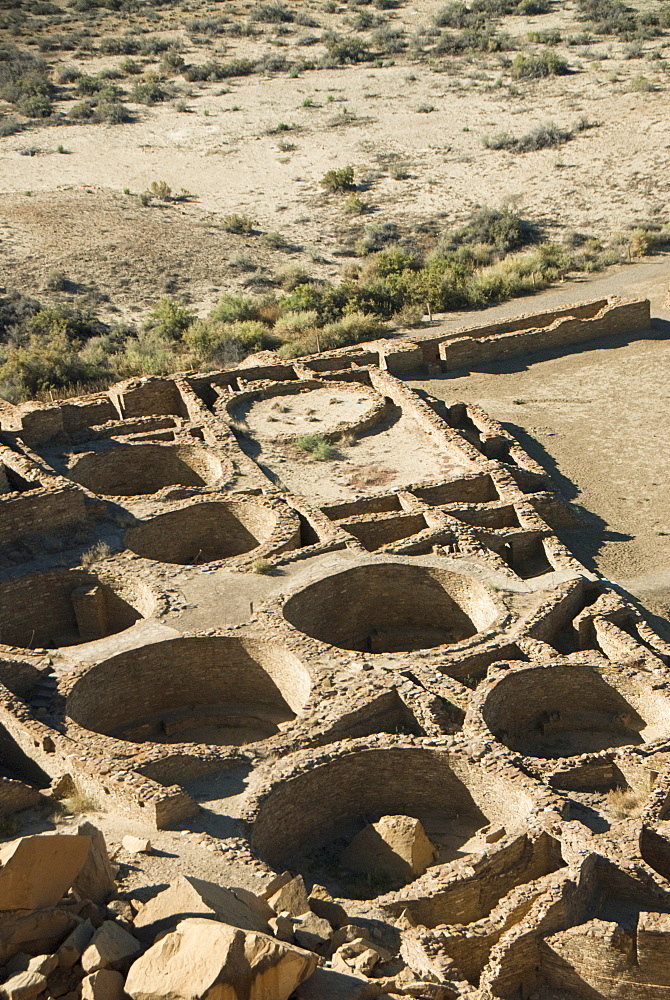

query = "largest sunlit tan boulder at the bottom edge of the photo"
(125, 917), (317, 1000)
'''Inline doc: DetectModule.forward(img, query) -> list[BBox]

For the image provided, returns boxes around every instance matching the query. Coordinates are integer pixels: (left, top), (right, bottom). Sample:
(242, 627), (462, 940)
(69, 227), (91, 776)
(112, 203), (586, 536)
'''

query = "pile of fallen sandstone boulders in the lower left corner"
(0, 832), (449, 1000)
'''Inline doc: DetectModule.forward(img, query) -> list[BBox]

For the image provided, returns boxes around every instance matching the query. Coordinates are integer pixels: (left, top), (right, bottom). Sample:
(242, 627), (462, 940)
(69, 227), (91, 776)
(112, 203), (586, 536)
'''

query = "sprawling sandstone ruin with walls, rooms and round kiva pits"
(0, 300), (670, 1000)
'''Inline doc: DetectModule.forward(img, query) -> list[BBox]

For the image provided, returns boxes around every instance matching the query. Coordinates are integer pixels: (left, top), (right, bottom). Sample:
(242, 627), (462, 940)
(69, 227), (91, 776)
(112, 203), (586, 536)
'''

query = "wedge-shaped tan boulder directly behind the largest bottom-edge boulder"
(135, 875), (275, 941)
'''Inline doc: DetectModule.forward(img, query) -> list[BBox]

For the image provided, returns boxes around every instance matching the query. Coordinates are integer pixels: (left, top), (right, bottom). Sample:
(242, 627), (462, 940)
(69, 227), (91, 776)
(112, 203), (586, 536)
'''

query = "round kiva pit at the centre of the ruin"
(284, 563), (499, 653)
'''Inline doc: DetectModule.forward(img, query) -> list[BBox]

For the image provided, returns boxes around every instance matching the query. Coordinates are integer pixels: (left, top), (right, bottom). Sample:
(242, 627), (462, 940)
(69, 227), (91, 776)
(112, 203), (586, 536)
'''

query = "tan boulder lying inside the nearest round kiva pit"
(341, 816), (436, 881)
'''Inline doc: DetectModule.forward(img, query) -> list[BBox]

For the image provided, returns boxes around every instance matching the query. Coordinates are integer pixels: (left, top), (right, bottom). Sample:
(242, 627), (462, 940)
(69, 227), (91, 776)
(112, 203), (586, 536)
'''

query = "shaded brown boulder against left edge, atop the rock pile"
(0, 834), (90, 910)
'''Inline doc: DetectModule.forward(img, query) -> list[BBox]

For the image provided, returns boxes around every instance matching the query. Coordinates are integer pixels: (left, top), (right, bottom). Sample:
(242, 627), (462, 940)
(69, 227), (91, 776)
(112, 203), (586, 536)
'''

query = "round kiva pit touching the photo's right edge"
(482, 664), (670, 760)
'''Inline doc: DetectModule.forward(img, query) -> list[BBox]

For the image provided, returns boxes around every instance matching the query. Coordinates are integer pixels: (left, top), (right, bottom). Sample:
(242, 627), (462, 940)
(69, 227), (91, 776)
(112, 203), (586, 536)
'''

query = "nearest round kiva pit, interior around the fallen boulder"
(251, 746), (533, 899)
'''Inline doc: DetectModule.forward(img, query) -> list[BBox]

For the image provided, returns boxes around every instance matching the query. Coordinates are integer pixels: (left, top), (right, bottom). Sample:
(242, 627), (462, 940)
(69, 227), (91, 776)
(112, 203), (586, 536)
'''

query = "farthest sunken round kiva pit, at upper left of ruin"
(69, 444), (223, 497)
